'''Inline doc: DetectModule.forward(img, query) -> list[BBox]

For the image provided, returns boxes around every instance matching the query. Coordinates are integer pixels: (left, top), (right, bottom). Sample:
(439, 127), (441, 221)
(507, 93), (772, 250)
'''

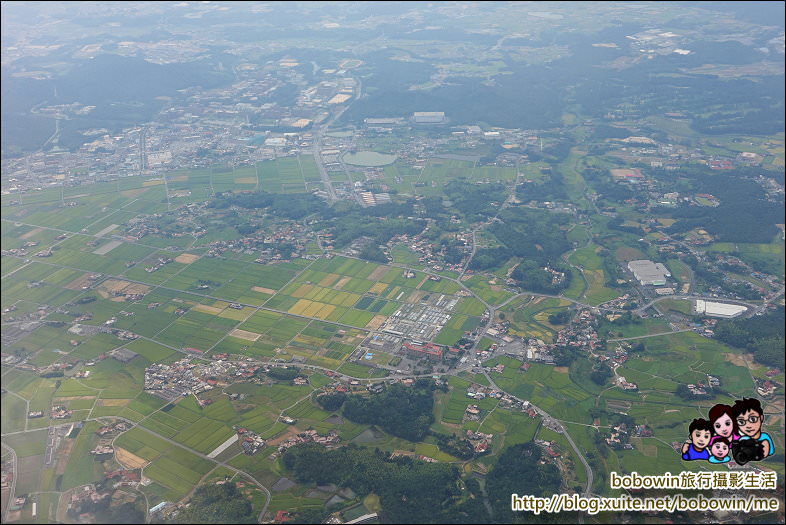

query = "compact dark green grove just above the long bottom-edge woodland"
(343, 379), (434, 442)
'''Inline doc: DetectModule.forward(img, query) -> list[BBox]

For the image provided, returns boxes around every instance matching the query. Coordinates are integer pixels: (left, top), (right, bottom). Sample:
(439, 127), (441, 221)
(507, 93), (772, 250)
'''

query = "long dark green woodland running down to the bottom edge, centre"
(283, 443), (478, 523)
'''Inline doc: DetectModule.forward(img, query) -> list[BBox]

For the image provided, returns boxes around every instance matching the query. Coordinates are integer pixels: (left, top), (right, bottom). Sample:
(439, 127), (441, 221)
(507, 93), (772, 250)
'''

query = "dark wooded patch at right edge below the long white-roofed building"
(715, 307), (786, 370)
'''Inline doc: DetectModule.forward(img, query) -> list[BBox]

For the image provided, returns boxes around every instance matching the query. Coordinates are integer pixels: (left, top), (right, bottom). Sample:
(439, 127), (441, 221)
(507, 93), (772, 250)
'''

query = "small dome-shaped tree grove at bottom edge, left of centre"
(168, 482), (257, 523)
